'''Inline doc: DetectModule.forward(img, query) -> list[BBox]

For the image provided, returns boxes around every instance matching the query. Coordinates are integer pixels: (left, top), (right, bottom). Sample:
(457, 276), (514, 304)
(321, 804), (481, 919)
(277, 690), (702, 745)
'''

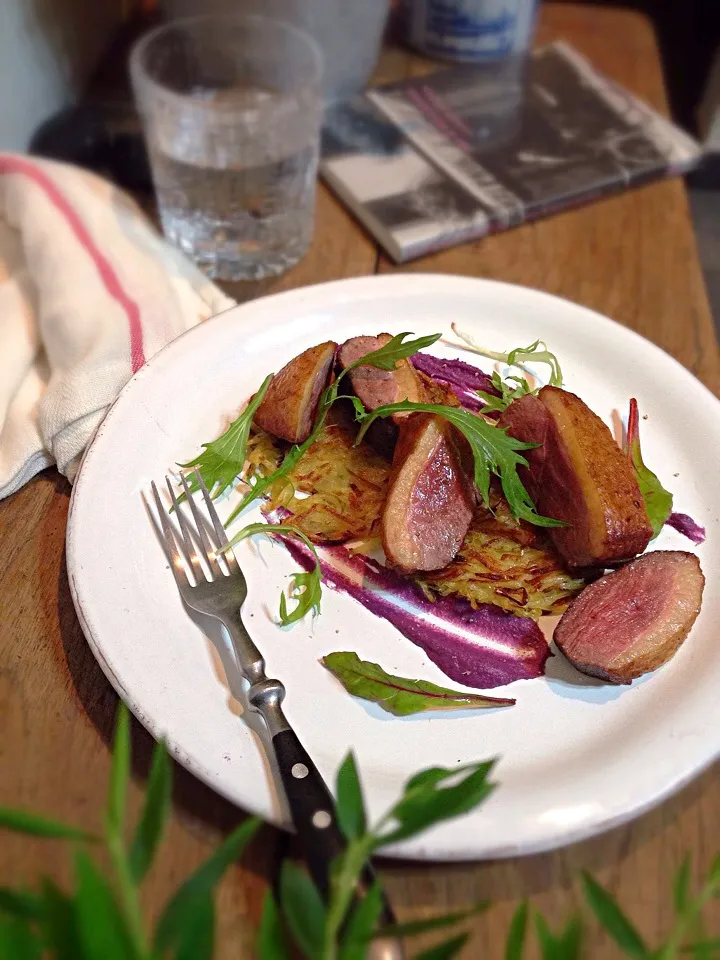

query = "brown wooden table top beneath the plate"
(0, 4), (720, 960)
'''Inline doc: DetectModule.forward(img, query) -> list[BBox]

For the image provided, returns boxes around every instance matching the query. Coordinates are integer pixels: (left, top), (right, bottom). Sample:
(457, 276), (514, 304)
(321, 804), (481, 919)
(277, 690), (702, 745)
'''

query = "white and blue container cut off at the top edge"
(404, 0), (537, 63)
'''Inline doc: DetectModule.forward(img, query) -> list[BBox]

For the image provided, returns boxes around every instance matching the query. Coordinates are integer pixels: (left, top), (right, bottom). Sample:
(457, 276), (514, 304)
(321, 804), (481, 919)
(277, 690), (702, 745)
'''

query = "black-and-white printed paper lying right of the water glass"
(321, 42), (701, 262)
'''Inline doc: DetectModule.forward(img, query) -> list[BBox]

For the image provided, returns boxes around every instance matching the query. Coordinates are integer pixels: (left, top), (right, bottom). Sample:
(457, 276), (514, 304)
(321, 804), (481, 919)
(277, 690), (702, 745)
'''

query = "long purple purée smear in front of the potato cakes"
(282, 537), (550, 690)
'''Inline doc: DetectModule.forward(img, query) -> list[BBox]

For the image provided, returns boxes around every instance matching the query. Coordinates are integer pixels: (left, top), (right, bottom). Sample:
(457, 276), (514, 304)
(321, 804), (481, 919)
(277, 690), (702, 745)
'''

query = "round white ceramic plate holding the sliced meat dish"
(68, 274), (720, 859)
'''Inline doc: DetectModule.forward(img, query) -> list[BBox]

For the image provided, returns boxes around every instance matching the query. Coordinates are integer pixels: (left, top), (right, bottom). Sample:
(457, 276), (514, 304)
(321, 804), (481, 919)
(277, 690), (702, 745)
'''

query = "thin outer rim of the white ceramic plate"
(65, 272), (720, 862)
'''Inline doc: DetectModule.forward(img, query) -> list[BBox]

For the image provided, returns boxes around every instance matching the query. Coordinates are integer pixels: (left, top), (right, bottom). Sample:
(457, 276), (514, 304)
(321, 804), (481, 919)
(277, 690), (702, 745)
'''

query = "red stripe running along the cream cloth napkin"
(0, 155), (145, 373)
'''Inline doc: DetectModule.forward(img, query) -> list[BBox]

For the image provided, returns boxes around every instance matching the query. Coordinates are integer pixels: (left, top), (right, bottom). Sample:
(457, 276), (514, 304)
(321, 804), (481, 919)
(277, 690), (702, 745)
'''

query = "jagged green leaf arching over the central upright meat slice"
(356, 400), (563, 527)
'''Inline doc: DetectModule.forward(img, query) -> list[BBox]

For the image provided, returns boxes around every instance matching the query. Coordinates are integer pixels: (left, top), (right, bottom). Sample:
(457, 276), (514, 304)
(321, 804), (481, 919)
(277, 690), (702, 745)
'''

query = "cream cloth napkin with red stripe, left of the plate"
(0, 153), (234, 498)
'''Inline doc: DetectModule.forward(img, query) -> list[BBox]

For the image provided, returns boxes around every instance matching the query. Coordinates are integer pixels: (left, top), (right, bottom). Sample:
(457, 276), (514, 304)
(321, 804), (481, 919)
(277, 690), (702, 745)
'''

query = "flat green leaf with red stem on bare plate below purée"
(320, 650), (515, 717)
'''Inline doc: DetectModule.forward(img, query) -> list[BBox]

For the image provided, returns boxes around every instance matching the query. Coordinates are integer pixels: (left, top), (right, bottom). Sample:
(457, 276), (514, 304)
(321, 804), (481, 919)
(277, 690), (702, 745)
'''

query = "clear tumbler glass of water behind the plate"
(130, 16), (322, 281)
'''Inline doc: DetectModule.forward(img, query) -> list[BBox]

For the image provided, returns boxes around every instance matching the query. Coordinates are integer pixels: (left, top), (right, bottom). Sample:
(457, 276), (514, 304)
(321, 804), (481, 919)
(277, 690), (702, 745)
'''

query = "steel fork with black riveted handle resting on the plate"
(152, 470), (403, 960)
